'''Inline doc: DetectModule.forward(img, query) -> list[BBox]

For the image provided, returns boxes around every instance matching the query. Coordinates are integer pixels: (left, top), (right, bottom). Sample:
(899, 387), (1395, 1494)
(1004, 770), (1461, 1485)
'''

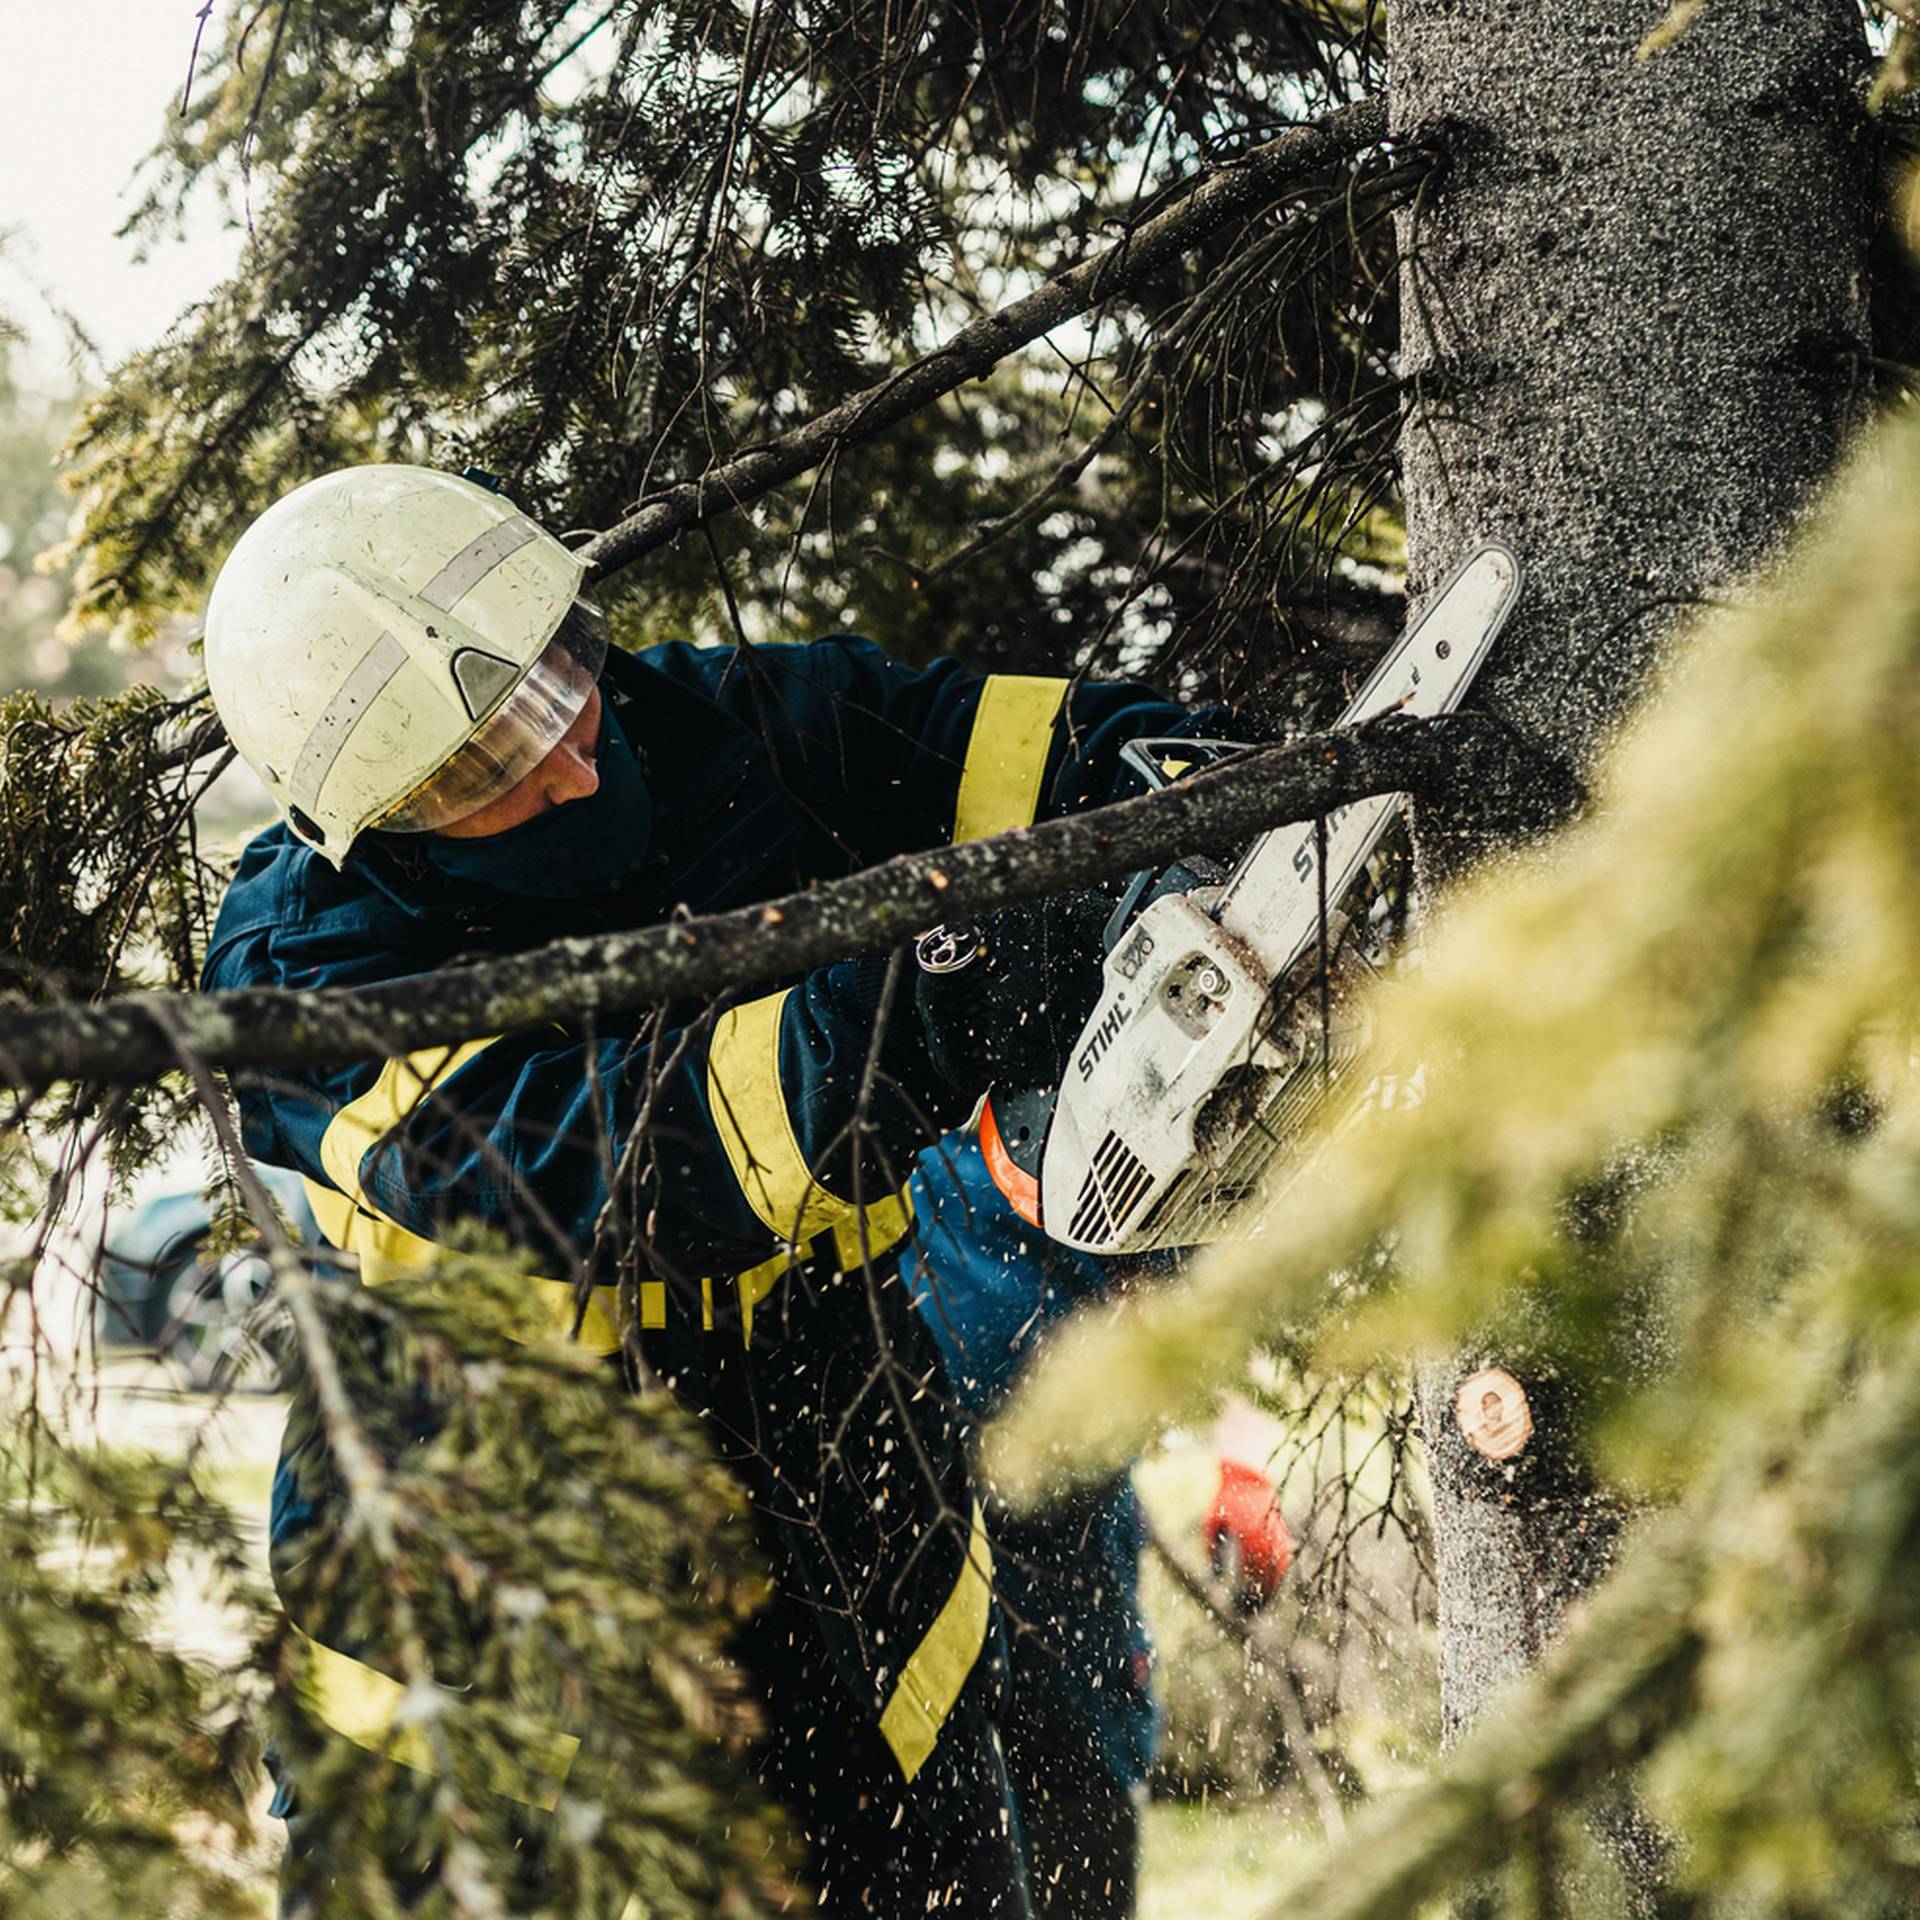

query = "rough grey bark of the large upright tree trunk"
(1390, 0), (1872, 1766)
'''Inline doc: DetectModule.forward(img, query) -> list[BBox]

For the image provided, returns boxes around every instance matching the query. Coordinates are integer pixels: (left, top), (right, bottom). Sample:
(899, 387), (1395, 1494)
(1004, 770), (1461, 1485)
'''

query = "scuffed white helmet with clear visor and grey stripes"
(207, 467), (607, 866)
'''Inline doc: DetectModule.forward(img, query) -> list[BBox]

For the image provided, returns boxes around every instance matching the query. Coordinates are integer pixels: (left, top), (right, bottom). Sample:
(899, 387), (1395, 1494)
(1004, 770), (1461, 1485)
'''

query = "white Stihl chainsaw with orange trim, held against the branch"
(979, 543), (1521, 1254)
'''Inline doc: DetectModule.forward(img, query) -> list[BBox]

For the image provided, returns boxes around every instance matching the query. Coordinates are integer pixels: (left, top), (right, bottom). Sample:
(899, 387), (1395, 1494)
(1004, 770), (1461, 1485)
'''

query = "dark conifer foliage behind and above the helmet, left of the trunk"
(73, 0), (1417, 691)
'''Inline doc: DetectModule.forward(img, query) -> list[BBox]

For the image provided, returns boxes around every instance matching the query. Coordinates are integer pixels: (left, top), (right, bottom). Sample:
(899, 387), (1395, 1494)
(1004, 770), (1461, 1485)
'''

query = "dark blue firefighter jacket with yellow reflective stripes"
(204, 636), (1217, 1797)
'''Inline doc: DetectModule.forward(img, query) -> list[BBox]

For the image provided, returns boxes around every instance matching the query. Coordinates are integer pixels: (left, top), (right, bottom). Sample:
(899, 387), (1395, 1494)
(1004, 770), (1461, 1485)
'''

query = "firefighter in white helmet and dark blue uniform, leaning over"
(204, 465), (1217, 1920)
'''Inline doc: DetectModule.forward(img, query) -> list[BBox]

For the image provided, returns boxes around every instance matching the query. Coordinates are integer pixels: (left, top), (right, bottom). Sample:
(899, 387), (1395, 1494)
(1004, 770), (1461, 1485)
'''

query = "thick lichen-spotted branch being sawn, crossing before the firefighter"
(0, 714), (1572, 1089)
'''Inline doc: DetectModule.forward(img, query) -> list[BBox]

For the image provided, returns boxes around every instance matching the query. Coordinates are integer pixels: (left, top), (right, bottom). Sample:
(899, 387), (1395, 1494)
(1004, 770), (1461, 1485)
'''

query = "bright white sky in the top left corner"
(0, 0), (242, 376)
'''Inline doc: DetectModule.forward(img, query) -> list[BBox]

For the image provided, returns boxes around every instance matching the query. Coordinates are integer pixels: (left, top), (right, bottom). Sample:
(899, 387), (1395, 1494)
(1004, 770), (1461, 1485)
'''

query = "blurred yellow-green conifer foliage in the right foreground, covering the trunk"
(993, 413), (1920, 1920)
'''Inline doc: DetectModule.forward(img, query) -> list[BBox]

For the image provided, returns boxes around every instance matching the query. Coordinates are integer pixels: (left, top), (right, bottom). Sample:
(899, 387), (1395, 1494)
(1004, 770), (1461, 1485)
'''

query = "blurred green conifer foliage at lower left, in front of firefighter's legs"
(0, 1235), (804, 1920)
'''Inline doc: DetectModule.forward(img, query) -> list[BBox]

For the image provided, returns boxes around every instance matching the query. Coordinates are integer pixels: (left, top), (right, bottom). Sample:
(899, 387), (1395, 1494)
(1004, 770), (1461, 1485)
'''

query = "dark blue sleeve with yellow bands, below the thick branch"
(360, 960), (964, 1277)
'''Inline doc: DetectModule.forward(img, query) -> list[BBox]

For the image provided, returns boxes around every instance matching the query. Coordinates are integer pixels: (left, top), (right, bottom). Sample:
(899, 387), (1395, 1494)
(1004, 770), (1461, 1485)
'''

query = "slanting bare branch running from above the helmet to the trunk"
(582, 100), (1386, 578)
